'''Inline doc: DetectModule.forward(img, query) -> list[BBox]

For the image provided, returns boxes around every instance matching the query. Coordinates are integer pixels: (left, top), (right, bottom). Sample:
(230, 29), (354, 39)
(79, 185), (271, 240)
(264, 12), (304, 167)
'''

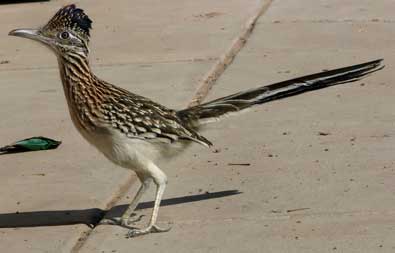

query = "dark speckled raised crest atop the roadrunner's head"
(44, 4), (92, 40)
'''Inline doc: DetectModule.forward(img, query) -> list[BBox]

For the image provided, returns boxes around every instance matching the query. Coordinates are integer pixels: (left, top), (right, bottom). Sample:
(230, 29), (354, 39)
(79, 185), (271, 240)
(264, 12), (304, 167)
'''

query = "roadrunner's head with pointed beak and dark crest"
(9, 4), (92, 56)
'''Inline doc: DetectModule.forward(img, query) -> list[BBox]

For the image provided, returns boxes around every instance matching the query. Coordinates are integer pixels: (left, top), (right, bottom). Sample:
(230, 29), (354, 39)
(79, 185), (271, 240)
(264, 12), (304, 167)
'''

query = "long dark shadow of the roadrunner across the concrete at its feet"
(0, 190), (242, 228)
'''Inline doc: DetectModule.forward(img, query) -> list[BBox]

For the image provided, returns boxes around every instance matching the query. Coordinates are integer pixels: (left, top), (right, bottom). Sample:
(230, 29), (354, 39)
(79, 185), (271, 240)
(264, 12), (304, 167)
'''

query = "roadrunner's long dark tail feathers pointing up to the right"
(177, 59), (384, 125)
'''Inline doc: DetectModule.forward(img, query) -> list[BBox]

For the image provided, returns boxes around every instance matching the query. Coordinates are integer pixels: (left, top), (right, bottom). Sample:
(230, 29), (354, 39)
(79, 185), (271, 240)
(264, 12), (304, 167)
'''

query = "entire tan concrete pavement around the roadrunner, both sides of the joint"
(0, 0), (395, 252)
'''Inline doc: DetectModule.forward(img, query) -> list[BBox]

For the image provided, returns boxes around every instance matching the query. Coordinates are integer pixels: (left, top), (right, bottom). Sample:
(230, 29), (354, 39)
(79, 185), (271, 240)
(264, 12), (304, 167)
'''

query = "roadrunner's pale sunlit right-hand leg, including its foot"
(126, 163), (171, 238)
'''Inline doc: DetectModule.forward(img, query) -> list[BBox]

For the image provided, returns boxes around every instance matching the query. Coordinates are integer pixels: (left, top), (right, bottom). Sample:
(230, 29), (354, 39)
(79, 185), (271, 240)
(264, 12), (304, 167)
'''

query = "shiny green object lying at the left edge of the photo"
(0, 136), (62, 153)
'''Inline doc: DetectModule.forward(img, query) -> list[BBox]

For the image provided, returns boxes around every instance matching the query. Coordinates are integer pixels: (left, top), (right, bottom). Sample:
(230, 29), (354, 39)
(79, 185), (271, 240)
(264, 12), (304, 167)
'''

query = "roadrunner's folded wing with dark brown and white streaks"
(101, 89), (212, 146)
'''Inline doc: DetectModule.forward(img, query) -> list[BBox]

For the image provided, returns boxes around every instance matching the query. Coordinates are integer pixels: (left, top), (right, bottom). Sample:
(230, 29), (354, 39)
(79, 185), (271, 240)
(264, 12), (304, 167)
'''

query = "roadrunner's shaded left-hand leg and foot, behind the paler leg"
(100, 173), (152, 227)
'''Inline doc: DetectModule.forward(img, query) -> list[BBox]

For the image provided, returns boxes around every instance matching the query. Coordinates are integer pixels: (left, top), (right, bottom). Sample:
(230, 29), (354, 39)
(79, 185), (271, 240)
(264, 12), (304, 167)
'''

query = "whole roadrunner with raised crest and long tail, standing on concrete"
(9, 5), (383, 237)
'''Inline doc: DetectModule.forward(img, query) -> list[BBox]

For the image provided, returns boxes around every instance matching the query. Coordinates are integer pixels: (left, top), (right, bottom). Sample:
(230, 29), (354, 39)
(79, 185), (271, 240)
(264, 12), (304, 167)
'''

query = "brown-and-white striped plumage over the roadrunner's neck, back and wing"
(59, 47), (211, 146)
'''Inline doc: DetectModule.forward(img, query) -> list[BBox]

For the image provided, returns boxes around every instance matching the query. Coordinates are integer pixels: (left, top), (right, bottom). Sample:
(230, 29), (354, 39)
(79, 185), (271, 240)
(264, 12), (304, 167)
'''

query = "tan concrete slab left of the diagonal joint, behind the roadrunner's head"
(0, 0), (266, 252)
